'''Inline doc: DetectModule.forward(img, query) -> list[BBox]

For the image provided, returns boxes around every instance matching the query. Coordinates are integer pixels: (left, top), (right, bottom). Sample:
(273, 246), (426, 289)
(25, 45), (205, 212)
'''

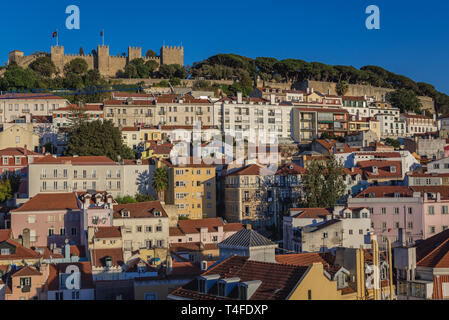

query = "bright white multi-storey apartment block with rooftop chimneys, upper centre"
(213, 93), (293, 143)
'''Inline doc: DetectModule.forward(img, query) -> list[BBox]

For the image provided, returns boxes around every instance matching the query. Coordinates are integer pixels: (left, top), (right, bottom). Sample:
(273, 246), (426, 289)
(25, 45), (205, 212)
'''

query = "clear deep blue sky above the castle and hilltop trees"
(0, 0), (449, 93)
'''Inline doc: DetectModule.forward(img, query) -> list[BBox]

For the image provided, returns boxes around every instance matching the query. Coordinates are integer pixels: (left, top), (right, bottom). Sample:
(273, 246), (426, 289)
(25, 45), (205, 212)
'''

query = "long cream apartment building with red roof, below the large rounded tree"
(28, 156), (153, 197)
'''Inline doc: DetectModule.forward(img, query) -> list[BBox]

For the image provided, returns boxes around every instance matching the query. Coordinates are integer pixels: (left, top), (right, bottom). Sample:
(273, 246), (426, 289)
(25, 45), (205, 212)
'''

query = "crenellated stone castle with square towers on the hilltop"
(8, 45), (184, 78)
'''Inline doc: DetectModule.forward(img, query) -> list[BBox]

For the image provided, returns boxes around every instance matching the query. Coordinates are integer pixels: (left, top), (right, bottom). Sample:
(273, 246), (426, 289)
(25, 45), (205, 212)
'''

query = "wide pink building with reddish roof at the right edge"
(348, 186), (449, 247)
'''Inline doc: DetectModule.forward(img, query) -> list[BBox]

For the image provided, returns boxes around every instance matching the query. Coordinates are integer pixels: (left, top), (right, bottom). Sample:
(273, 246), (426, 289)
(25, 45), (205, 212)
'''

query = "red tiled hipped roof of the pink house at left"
(11, 193), (79, 214)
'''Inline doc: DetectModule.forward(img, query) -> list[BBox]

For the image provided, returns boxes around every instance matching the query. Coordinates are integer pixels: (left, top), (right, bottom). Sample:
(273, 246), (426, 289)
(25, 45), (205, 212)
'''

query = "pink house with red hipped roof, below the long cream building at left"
(11, 193), (82, 247)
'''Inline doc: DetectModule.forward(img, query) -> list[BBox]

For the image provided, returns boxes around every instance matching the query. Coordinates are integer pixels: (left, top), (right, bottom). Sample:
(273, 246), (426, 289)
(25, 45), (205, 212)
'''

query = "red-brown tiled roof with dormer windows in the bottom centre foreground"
(172, 256), (309, 300)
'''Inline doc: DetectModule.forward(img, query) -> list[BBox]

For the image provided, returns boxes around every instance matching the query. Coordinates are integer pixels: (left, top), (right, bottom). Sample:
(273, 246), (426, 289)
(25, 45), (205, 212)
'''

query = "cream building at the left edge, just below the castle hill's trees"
(0, 93), (69, 123)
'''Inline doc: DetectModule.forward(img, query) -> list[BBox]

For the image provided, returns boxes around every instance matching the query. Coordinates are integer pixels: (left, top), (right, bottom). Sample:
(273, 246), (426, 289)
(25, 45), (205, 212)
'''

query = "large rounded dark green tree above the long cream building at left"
(65, 120), (135, 161)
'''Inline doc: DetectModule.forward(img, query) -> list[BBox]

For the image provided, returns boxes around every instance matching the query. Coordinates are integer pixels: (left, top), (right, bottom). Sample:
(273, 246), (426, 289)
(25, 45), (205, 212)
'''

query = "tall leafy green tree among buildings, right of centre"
(303, 157), (346, 208)
